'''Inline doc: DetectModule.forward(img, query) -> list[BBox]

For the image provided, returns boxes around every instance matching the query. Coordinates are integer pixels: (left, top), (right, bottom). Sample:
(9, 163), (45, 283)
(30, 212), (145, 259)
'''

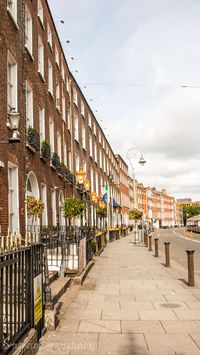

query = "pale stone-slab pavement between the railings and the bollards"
(38, 235), (200, 355)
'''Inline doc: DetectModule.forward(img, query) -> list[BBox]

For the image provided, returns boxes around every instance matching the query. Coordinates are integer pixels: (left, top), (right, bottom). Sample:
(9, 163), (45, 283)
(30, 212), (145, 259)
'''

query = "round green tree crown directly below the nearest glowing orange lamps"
(62, 198), (86, 218)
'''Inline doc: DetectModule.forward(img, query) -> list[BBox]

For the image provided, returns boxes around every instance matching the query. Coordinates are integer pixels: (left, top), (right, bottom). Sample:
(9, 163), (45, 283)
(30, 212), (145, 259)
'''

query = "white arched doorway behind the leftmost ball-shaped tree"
(26, 171), (40, 226)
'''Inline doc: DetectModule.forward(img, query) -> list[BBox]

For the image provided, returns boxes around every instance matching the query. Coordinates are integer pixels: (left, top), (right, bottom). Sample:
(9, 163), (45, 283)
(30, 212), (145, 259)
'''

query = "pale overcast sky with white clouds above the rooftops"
(49, 0), (200, 200)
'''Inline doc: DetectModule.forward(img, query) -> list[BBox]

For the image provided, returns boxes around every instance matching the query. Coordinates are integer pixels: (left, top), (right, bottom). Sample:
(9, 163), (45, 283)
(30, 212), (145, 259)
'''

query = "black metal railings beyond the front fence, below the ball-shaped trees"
(27, 226), (95, 272)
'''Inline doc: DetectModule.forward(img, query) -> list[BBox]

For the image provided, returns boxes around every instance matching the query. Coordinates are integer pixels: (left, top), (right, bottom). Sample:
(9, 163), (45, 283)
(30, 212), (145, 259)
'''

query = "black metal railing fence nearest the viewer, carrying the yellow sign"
(0, 244), (44, 353)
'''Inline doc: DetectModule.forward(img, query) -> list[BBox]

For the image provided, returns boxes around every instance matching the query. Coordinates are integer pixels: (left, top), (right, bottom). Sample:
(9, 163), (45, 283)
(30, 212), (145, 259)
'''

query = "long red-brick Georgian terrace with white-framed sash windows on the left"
(0, 0), (120, 234)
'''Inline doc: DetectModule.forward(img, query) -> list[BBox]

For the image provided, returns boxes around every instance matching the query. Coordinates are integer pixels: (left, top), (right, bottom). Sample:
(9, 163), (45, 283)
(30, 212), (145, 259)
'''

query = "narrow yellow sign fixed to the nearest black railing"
(33, 274), (42, 325)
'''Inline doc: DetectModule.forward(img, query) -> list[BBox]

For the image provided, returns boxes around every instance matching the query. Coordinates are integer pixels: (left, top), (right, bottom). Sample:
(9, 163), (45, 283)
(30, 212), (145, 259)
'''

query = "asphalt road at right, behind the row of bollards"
(152, 228), (200, 276)
